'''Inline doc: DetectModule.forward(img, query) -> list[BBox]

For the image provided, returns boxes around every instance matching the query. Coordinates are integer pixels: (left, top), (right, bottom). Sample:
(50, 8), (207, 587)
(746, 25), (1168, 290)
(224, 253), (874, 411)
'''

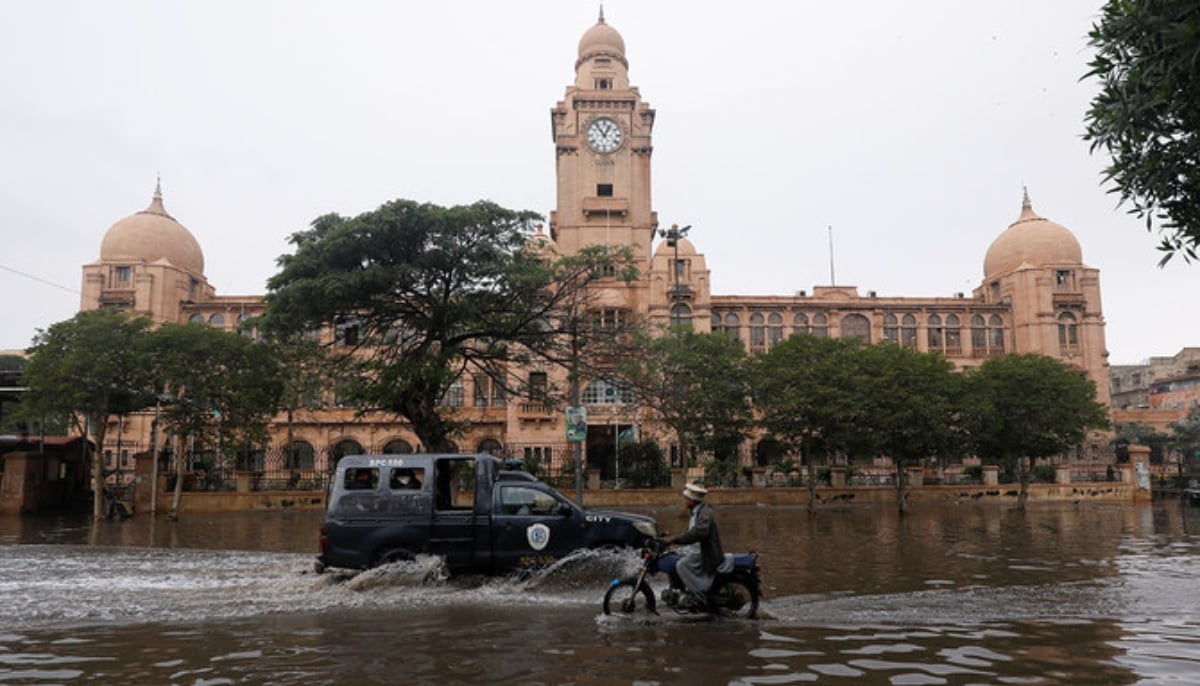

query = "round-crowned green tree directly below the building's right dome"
(965, 354), (1109, 509)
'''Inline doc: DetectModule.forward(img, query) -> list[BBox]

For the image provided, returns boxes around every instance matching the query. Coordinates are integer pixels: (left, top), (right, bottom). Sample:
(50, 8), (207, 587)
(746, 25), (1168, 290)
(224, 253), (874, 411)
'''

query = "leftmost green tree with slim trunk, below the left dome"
(19, 308), (154, 519)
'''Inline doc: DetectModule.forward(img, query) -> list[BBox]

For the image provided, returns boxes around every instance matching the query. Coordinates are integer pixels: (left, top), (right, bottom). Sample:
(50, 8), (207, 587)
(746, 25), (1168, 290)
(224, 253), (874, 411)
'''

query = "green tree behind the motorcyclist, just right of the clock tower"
(623, 331), (754, 473)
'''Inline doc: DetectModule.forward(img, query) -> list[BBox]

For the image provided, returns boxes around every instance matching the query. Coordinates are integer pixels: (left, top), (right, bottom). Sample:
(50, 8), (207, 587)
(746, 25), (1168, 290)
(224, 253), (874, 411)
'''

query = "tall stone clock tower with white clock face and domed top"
(550, 8), (658, 281)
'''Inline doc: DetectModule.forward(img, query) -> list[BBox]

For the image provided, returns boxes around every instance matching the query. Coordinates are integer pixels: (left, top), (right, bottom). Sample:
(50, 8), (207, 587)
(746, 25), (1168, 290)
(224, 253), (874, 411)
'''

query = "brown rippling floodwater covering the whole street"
(0, 503), (1200, 685)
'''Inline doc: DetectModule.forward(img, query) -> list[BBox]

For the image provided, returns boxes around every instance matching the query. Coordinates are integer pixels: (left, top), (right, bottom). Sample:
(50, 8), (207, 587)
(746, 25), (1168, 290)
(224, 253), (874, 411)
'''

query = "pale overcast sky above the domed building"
(0, 0), (1200, 363)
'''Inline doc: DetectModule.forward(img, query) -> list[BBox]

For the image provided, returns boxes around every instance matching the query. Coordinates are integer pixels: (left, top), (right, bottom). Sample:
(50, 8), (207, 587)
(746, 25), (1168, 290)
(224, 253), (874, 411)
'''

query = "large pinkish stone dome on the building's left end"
(100, 186), (204, 276)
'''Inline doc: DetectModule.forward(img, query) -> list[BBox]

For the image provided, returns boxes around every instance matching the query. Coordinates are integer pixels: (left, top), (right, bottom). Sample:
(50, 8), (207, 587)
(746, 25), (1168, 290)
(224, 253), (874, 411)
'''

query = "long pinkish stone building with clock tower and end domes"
(83, 14), (1109, 482)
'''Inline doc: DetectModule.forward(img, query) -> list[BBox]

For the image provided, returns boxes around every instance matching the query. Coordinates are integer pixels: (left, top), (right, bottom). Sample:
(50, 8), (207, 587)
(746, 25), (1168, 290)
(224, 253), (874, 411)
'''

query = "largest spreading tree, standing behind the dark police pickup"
(260, 200), (628, 451)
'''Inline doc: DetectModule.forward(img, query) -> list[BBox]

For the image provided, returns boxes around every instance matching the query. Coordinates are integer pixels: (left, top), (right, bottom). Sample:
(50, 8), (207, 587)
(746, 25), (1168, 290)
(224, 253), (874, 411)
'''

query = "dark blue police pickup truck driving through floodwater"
(316, 455), (659, 574)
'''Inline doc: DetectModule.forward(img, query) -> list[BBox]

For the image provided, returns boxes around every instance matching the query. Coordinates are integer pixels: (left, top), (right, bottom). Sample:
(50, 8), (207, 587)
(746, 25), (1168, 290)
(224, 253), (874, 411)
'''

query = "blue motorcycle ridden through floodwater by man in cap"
(604, 540), (762, 619)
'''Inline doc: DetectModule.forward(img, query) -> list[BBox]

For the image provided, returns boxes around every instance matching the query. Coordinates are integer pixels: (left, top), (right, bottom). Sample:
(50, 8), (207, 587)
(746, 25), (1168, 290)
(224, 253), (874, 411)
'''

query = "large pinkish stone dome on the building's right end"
(983, 193), (1084, 278)
